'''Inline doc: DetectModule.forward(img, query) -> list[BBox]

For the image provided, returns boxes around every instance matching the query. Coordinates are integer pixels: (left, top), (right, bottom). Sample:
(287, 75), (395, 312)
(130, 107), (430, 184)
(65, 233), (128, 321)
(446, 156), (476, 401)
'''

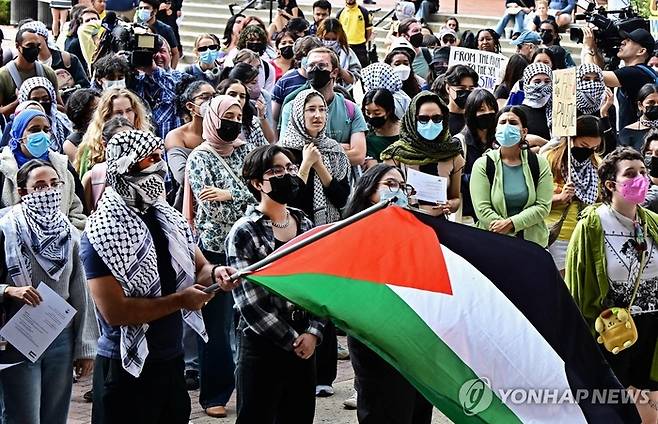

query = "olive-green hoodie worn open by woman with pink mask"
(564, 203), (658, 381)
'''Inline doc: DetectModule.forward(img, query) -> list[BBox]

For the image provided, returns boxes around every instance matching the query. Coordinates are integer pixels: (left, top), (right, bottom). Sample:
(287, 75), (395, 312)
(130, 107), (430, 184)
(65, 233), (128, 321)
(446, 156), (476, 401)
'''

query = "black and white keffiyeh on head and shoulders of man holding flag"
(85, 130), (208, 377)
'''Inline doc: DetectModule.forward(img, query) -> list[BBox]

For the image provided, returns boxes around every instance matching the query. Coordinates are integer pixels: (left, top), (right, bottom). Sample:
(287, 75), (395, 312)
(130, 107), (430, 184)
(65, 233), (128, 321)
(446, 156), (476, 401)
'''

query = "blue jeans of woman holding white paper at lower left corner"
(0, 327), (73, 424)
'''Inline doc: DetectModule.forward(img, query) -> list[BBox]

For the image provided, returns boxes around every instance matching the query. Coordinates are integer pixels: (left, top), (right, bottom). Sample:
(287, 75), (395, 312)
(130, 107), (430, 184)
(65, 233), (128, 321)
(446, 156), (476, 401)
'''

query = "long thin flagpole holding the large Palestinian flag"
(203, 197), (397, 293)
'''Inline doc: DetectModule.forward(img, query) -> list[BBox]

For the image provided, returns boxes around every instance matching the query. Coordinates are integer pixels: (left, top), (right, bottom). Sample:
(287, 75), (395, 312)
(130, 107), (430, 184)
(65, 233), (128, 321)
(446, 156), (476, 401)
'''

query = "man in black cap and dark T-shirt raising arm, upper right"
(582, 27), (658, 128)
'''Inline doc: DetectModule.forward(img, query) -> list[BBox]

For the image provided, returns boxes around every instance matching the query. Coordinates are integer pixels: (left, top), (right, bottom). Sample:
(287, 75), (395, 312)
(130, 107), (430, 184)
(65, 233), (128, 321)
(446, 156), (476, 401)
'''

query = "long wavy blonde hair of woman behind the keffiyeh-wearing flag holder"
(74, 88), (151, 177)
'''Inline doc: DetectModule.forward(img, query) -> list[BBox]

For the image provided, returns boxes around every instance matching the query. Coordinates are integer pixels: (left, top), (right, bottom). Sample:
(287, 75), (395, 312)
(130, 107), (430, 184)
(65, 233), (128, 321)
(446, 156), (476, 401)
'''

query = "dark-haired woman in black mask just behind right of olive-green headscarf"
(437, 65), (479, 134)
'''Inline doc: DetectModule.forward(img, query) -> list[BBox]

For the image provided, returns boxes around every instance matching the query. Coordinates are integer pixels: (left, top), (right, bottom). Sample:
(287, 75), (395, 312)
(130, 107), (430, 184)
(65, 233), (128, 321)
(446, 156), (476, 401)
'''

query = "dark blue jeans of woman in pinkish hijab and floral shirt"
(198, 247), (235, 409)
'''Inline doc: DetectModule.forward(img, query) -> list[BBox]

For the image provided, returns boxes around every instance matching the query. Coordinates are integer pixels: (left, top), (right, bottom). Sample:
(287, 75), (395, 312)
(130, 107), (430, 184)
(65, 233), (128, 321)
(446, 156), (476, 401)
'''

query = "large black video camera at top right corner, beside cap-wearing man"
(569, 3), (649, 70)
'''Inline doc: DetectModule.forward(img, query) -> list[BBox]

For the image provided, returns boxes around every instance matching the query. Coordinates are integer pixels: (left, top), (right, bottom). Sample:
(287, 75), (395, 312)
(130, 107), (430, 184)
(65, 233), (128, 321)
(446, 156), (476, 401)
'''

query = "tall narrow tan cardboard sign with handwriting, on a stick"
(553, 68), (576, 137)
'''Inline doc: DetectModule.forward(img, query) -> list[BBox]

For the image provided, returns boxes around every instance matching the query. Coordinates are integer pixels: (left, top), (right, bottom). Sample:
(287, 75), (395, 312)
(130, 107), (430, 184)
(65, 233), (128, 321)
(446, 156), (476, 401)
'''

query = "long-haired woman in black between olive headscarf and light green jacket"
(453, 88), (498, 225)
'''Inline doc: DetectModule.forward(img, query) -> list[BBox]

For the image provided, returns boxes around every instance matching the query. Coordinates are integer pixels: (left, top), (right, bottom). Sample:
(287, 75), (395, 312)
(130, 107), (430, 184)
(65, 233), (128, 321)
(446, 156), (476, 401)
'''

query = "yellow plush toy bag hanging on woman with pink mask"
(594, 308), (637, 355)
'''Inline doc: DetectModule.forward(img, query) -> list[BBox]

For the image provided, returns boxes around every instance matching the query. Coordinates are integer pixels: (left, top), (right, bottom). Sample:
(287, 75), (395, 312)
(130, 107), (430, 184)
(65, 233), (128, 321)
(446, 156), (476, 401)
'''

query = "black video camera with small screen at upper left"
(94, 12), (162, 68)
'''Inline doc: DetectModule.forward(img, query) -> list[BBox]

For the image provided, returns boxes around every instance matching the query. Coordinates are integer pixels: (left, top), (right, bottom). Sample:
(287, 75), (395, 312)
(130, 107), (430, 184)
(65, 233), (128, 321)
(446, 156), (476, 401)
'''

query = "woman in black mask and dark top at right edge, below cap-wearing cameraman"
(619, 84), (658, 151)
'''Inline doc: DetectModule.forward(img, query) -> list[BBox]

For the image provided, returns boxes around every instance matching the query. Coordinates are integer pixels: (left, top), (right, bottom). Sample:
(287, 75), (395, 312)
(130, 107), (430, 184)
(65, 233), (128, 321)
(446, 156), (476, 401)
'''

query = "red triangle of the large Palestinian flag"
(254, 206), (452, 294)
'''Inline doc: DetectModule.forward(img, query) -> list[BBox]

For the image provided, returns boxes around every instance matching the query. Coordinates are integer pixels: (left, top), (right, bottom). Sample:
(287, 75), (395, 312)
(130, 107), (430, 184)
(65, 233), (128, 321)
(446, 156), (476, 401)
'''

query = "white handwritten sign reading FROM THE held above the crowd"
(448, 47), (507, 92)
